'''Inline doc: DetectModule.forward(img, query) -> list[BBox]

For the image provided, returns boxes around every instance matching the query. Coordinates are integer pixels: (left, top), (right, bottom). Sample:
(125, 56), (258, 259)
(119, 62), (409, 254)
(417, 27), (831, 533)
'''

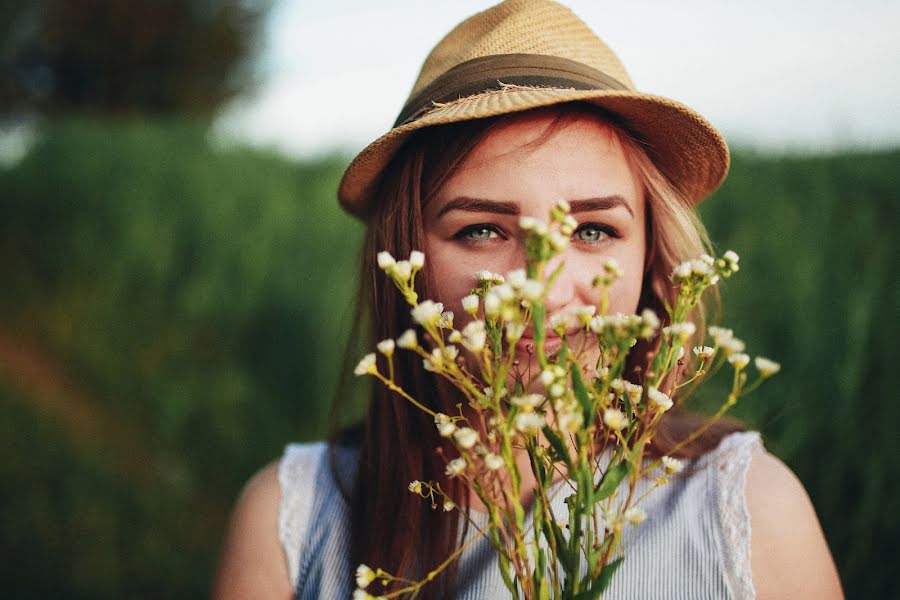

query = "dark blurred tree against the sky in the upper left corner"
(0, 0), (270, 117)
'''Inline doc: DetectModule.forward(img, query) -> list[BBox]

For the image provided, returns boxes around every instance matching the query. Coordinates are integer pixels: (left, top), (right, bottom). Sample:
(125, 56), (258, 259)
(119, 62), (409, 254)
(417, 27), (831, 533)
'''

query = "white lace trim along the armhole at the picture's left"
(278, 442), (325, 589)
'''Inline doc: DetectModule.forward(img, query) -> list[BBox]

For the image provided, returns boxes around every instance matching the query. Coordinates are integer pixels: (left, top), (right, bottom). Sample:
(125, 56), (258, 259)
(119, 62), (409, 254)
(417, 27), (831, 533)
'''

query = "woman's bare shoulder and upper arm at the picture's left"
(212, 461), (292, 600)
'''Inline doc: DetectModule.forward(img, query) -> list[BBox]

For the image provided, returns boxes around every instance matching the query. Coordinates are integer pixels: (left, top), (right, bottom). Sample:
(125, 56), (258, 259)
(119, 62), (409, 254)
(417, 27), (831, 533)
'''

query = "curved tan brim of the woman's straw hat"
(338, 87), (730, 218)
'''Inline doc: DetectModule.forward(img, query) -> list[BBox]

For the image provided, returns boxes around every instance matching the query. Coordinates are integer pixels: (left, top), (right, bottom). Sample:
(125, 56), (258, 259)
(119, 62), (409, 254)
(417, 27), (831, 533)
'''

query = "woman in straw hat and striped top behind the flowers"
(216, 0), (842, 598)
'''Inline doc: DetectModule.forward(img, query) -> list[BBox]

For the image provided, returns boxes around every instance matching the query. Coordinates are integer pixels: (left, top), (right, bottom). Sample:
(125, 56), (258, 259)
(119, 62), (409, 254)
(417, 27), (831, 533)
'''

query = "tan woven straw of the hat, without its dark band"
(338, 0), (729, 217)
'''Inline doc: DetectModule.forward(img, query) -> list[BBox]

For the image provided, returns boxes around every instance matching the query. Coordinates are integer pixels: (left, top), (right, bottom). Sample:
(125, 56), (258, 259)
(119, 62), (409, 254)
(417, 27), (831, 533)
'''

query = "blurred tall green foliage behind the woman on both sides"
(0, 121), (900, 598)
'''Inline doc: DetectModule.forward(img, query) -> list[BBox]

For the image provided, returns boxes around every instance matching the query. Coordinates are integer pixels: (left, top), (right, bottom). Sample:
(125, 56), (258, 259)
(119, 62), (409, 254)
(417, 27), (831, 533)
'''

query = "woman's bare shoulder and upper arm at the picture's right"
(747, 449), (844, 600)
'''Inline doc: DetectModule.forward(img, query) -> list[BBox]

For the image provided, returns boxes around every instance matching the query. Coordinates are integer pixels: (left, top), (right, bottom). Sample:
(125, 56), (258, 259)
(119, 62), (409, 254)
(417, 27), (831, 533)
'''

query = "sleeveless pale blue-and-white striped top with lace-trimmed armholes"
(279, 432), (761, 600)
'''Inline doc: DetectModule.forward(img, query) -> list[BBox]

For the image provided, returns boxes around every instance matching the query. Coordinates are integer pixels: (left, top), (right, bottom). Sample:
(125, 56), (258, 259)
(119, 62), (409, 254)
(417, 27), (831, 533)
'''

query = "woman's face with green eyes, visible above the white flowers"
(424, 114), (646, 372)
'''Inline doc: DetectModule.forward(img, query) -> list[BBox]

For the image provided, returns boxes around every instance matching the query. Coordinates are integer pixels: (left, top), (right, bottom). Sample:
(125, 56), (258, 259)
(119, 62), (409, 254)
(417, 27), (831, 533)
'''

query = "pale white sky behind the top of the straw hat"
(217, 0), (900, 157)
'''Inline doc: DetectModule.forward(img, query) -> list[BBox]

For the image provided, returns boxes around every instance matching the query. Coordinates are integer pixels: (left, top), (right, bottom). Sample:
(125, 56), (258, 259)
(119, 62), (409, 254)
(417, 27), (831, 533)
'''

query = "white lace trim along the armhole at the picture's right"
(707, 431), (763, 600)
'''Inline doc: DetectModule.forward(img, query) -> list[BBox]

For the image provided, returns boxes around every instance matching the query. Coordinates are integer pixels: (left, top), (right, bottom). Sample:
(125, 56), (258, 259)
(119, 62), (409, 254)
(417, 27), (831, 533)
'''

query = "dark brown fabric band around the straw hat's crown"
(394, 54), (629, 127)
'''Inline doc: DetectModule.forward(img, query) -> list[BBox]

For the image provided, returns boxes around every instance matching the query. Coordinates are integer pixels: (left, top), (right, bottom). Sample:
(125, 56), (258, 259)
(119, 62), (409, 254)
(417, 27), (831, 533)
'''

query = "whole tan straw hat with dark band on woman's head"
(338, 0), (729, 217)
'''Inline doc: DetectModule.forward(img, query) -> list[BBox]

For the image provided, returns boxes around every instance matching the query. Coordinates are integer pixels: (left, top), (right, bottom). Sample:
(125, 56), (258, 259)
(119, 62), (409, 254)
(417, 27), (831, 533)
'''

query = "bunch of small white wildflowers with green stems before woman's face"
(354, 202), (779, 600)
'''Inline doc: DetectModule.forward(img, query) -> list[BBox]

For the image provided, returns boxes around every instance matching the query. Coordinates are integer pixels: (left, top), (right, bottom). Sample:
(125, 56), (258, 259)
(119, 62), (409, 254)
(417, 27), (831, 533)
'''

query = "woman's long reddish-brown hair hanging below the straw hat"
(332, 104), (740, 598)
